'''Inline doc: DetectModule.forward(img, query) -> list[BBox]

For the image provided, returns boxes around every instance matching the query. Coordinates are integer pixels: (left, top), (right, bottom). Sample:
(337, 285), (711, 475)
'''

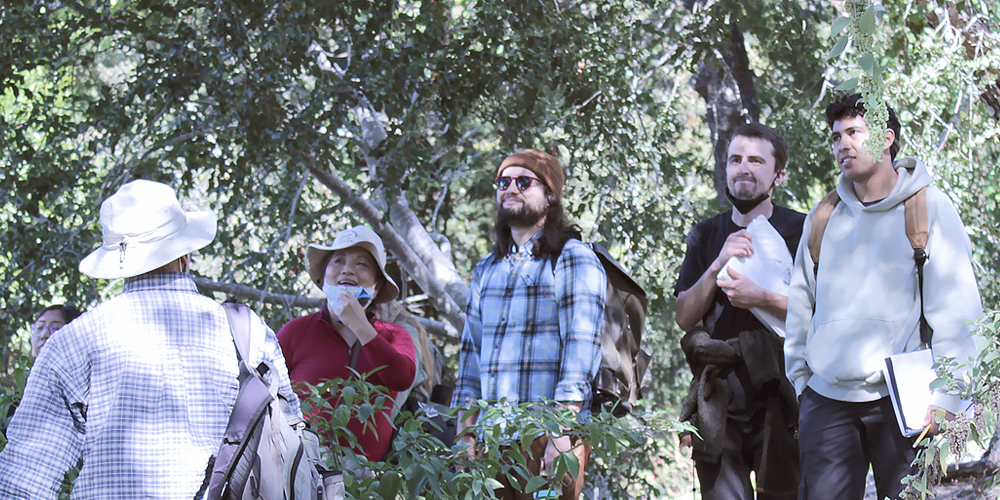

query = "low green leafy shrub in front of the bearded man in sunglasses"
(292, 379), (688, 499)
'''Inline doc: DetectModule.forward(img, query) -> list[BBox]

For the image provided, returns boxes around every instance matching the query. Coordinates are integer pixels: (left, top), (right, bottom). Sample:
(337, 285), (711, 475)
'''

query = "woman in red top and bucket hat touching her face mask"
(278, 226), (416, 461)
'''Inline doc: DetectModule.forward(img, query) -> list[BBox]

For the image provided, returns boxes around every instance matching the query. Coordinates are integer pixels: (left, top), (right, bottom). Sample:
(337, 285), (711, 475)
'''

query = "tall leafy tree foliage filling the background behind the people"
(0, 0), (1000, 491)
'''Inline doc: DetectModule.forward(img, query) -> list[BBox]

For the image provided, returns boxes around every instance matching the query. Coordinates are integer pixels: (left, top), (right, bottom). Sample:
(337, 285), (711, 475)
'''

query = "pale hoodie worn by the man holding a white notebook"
(785, 158), (982, 403)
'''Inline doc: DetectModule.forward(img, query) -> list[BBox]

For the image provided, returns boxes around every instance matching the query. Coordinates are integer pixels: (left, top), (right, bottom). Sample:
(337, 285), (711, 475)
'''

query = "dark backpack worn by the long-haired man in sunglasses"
(552, 243), (652, 417)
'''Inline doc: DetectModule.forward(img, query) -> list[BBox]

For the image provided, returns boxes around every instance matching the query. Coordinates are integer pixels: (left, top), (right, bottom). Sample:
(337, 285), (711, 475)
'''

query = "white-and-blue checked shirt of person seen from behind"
(0, 273), (298, 499)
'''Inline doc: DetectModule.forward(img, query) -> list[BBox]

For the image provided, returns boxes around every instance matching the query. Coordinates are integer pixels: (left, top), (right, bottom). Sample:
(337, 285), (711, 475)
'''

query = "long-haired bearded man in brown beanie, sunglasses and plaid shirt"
(452, 149), (607, 500)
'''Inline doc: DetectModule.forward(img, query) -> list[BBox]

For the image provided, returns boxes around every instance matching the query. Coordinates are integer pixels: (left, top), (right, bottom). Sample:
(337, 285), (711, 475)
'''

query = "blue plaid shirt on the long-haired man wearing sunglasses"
(452, 235), (608, 411)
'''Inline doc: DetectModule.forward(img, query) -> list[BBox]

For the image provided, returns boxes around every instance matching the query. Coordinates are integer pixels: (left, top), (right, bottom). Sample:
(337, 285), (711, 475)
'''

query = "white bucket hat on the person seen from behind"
(80, 179), (218, 279)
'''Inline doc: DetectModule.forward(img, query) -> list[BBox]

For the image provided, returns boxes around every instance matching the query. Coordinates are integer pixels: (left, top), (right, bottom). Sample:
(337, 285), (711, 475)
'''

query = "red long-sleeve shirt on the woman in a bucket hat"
(278, 308), (416, 461)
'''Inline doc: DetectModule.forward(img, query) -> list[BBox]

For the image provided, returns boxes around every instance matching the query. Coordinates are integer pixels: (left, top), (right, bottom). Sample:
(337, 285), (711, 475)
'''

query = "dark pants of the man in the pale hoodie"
(799, 387), (916, 500)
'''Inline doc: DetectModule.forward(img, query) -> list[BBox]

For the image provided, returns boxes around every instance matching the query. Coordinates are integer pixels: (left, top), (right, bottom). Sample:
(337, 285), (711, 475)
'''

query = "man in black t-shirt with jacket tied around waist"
(674, 123), (805, 500)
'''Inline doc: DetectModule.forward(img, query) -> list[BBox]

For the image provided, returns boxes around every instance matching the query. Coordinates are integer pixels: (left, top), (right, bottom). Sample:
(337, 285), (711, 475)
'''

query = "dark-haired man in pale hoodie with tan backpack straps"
(785, 94), (982, 500)
